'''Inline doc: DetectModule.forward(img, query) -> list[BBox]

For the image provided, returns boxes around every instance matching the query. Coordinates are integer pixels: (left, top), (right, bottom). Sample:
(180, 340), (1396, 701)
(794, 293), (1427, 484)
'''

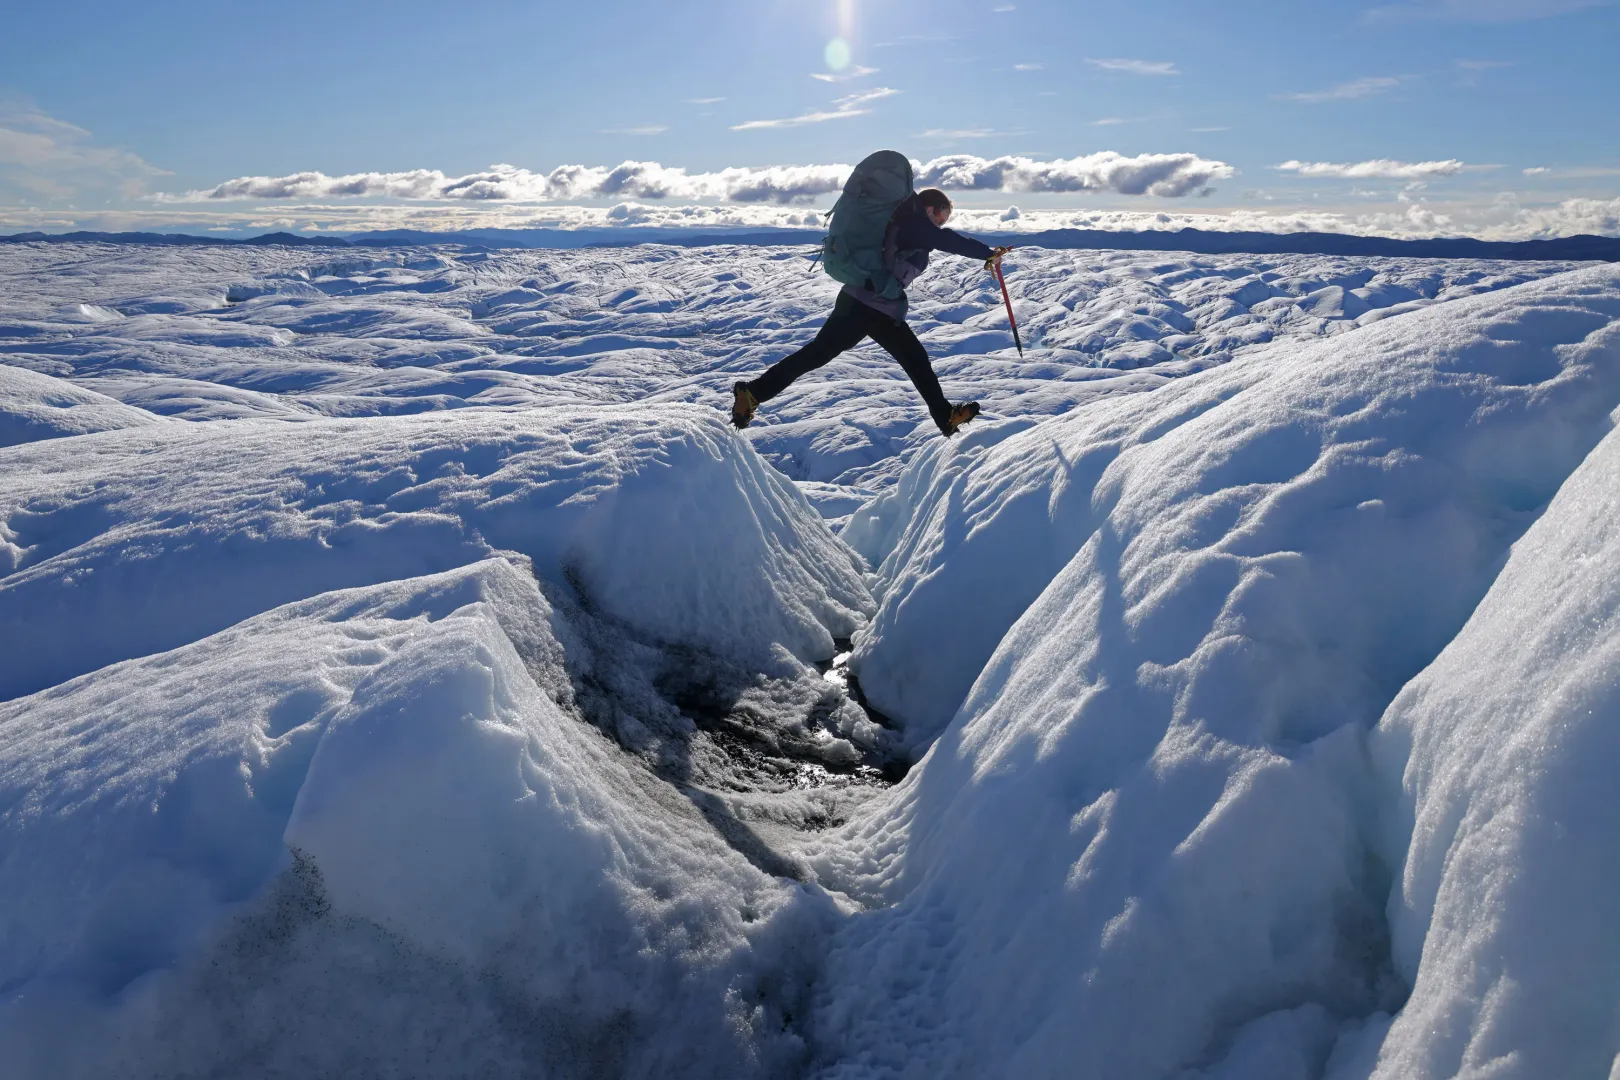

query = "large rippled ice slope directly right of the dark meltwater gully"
(816, 267), (1620, 1078)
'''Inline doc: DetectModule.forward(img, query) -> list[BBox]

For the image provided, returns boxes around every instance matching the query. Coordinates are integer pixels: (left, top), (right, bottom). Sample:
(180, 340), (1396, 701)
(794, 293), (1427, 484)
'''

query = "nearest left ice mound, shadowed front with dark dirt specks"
(0, 559), (821, 1077)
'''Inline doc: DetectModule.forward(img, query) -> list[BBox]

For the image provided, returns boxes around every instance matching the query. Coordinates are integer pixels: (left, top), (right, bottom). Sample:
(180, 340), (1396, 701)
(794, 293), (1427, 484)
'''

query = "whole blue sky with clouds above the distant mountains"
(0, 0), (1620, 236)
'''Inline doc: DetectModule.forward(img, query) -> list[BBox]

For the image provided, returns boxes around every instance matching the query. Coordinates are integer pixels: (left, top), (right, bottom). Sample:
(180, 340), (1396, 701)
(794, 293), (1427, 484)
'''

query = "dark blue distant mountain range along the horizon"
(0, 227), (1620, 262)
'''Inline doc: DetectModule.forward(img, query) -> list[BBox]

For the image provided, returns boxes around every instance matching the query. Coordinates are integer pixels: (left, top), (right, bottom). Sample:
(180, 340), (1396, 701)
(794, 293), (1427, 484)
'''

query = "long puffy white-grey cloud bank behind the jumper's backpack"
(157, 151), (1233, 204)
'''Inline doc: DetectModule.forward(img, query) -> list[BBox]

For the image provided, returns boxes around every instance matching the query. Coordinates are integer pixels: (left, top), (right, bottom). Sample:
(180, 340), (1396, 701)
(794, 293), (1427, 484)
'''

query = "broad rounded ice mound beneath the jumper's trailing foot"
(0, 405), (870, 699)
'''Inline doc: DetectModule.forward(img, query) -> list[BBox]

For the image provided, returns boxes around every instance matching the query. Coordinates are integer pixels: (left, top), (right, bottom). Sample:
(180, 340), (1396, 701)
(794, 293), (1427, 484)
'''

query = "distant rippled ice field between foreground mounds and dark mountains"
(0, 244), (1571, 521)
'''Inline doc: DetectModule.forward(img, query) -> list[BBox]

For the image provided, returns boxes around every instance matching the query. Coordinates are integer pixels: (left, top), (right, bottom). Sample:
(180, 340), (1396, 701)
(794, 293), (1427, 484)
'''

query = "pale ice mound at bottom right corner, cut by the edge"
(1372, 417), (1620, 1080)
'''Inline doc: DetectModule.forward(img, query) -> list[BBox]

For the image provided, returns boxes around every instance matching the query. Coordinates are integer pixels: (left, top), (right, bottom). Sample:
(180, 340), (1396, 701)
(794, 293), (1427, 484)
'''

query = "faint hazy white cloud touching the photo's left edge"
(0, 100), (170, 199)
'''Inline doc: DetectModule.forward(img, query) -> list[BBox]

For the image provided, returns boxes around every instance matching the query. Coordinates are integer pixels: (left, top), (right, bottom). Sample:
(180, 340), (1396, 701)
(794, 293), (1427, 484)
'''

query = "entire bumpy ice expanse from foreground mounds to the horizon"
(0, 244), (1620, 1080)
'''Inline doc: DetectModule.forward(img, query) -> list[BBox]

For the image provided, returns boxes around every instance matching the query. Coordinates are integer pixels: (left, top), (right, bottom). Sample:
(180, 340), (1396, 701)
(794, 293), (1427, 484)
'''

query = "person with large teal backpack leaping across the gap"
(731, 151), (1011, 437)
